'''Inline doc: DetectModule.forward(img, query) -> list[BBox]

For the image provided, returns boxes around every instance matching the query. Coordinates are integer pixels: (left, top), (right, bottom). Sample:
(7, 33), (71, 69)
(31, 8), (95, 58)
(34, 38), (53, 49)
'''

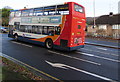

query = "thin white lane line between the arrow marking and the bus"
(48, 50), (101, 66)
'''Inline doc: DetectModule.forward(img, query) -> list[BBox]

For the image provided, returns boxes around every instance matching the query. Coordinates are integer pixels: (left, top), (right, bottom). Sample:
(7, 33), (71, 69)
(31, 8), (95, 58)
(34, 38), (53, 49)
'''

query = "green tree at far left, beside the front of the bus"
(2, 8), (13, 26)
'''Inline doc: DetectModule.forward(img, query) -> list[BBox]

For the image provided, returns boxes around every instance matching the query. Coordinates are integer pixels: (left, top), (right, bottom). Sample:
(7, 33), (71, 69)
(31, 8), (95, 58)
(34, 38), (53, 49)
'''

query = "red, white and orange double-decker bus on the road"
(8, 2), (86, 51)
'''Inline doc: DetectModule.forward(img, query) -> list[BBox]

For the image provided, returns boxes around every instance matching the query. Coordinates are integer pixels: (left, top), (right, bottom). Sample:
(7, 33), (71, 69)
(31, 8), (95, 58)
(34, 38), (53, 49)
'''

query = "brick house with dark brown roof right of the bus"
(87, 13), (120, 39)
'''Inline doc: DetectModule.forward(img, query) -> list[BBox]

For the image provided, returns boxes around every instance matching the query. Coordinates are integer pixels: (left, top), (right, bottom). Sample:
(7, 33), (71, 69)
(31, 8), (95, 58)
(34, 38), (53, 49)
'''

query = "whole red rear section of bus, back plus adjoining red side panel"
(55, 2), (86, 51)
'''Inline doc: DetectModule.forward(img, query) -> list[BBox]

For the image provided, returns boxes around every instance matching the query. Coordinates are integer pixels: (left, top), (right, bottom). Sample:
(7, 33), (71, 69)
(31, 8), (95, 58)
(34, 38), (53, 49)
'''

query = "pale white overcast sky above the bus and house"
(0, 0), (120, 17)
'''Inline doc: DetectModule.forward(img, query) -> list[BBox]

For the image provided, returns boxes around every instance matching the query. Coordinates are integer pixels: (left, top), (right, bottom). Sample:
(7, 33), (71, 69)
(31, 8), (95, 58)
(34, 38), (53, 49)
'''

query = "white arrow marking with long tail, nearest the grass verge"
(45, 61), (116, 82)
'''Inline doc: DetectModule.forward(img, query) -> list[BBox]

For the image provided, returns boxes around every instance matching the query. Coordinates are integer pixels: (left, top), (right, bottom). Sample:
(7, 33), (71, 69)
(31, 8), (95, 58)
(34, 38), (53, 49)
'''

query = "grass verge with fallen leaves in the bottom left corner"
(2, 57), (43, 82)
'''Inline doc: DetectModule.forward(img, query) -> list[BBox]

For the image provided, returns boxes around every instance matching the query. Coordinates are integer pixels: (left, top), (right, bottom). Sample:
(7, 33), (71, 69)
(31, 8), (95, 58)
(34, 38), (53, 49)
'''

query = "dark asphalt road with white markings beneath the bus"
(0, 34), (120, 81)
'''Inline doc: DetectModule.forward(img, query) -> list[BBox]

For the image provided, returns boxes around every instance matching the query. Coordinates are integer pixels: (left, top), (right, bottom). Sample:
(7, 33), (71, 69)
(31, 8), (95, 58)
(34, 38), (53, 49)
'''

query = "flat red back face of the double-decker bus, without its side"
(68, 2), (86, 50)
